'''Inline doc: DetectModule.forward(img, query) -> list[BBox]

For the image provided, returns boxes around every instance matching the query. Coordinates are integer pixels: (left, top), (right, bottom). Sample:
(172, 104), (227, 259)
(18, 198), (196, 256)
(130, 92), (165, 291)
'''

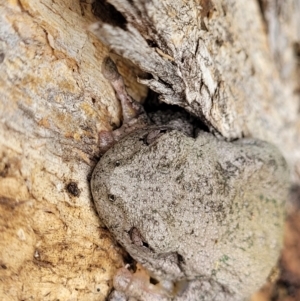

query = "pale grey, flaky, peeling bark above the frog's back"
(93, 0), (300, 185)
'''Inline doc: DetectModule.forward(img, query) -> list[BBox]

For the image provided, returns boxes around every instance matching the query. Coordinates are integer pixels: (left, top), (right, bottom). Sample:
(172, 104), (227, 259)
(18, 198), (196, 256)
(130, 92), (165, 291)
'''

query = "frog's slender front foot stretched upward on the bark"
(99, 57), (149, 153)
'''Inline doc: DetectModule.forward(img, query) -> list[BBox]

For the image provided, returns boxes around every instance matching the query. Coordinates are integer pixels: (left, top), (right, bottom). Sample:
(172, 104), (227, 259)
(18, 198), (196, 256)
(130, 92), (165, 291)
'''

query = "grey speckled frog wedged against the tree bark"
(91, 58), (289, 301)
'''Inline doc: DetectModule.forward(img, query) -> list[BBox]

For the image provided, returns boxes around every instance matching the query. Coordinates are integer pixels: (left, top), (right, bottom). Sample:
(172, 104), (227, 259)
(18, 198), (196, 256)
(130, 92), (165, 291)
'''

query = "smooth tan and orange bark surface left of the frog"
(0, 0), (146, 300)
